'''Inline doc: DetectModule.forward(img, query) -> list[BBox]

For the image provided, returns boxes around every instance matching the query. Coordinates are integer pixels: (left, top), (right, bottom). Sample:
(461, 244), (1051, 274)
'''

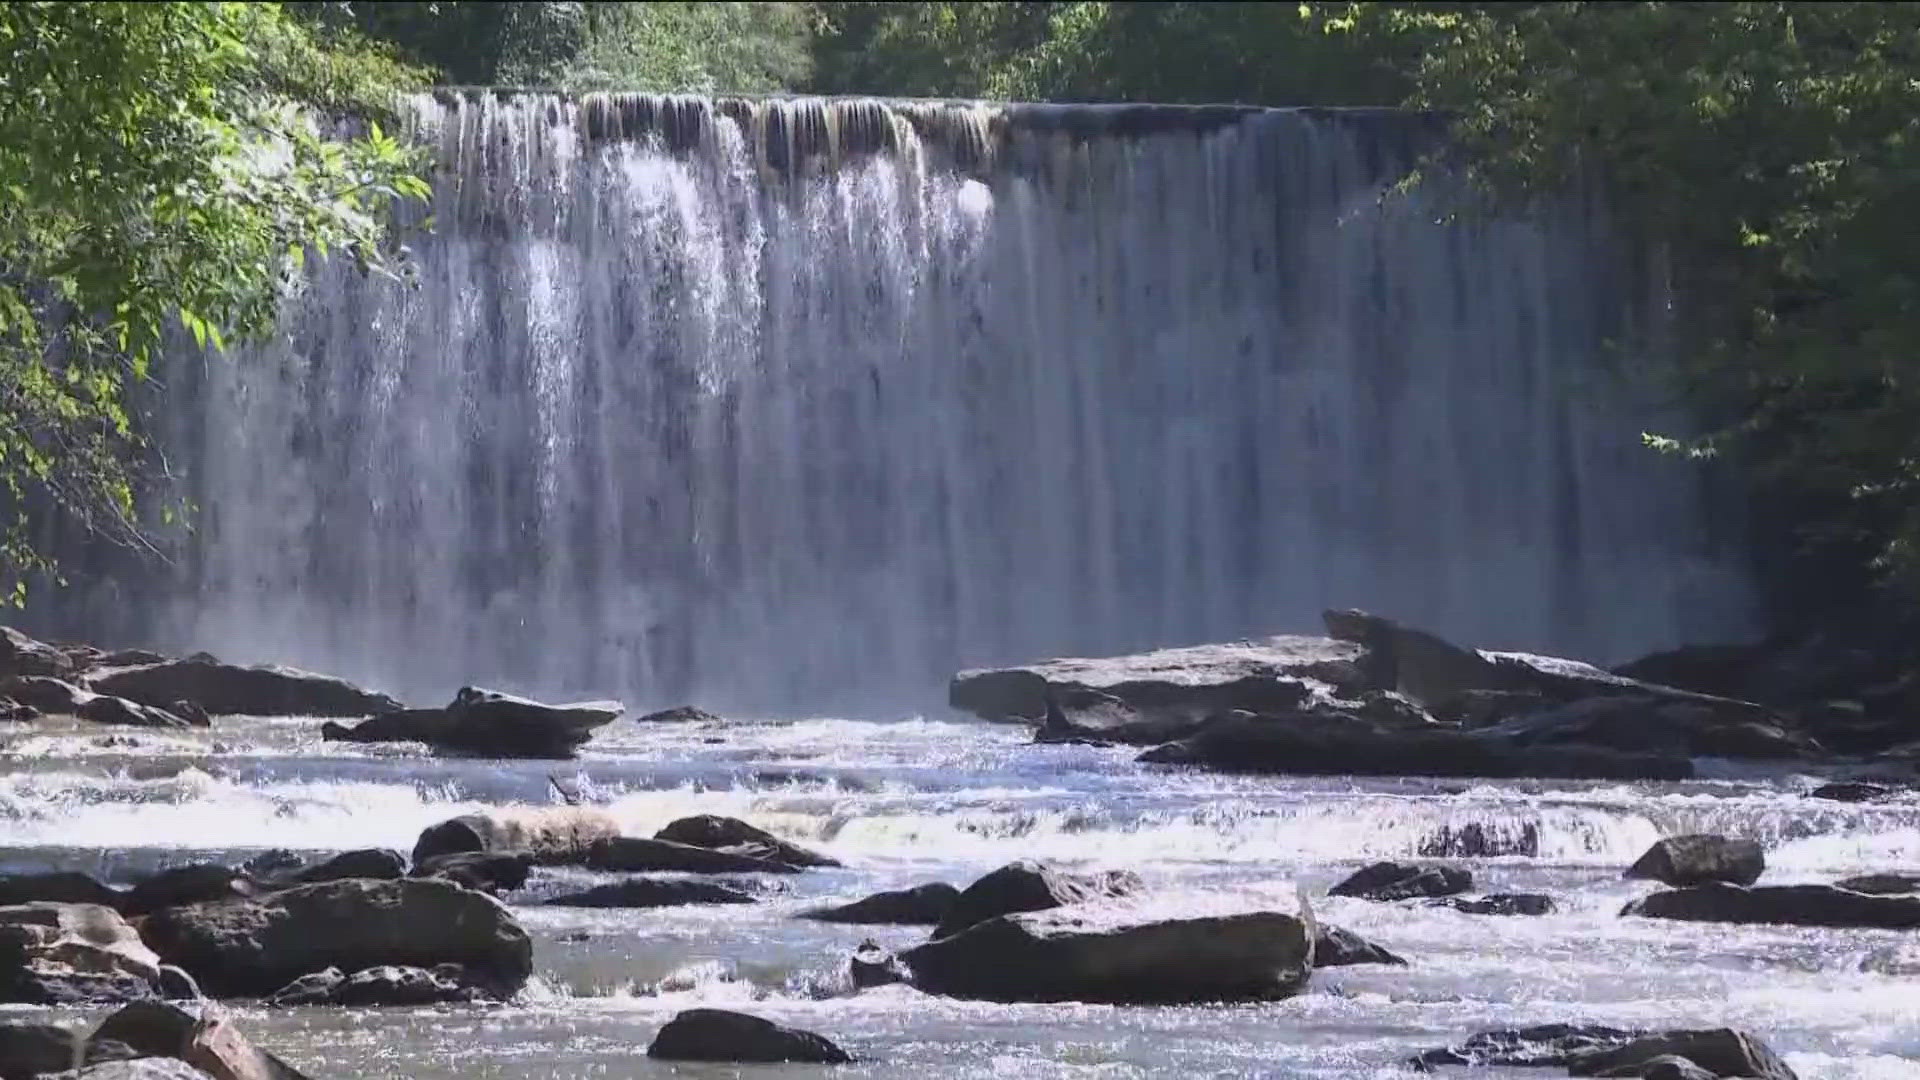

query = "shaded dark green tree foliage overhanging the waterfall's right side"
(1321, 2), (1920, 607)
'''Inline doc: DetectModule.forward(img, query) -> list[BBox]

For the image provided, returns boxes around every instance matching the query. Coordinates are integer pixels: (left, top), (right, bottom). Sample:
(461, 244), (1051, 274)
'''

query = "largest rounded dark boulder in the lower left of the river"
(142, 878), (534, 997)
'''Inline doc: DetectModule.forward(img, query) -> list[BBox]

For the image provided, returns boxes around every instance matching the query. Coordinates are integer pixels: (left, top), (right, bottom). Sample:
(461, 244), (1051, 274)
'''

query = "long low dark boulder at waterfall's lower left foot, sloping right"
(86, 657), (399, 717)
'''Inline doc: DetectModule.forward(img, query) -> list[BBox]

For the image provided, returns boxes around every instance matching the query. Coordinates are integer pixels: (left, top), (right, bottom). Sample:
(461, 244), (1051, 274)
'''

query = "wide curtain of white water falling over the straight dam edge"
(56, 92), (1745, 711)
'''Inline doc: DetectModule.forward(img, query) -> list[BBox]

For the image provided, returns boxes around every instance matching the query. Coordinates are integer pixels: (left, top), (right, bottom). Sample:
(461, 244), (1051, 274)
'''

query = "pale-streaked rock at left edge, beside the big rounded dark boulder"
(0, 903), (161, 1005)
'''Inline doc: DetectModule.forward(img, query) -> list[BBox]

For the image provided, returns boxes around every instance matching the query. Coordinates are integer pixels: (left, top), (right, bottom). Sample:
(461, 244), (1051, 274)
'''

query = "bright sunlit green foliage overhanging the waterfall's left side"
(0, 2), (426, 601)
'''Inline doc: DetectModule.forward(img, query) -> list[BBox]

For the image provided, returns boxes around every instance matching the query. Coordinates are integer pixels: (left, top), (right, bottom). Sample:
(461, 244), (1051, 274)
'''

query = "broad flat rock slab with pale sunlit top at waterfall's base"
(947, 636), (1365, 726)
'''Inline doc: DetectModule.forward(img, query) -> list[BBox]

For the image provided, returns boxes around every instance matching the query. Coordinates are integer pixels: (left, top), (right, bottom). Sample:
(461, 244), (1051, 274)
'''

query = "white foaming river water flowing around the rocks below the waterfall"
(0, 717), (1920, 1080)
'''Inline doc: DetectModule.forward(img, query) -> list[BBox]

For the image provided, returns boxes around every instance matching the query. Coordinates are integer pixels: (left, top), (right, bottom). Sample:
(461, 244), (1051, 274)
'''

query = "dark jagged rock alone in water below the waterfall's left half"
(321, 686), (626, 757)
